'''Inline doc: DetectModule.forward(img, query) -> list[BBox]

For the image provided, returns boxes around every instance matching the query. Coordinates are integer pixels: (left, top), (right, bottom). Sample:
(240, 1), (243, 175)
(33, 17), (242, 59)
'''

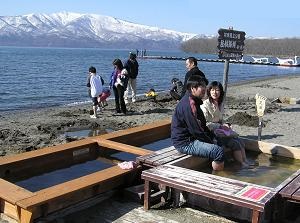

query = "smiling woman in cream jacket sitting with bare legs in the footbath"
(200, 81), (250, 167)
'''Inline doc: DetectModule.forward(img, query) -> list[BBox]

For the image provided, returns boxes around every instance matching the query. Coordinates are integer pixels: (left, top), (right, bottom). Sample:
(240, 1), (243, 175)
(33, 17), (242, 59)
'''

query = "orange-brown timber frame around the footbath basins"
(0, 120), (300, 223)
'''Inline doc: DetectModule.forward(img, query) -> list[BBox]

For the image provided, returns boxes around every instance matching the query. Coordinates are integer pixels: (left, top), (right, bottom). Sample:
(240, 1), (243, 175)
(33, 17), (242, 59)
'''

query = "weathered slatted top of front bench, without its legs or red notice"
(142, 165), (276, 211)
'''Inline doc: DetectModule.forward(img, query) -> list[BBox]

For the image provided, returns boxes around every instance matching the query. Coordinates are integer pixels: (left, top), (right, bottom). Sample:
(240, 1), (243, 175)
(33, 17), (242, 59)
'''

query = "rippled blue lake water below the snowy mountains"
(0, 47), (300, 112)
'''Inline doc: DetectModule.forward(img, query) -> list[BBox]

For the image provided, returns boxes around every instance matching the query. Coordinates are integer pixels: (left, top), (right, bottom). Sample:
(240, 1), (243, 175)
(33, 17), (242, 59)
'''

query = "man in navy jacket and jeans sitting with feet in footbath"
(171, 75), (224, 170)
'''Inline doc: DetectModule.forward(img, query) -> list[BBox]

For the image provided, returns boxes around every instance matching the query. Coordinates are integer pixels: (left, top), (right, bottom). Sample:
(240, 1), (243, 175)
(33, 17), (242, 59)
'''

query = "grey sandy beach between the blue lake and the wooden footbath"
(0, 75), (300, 222)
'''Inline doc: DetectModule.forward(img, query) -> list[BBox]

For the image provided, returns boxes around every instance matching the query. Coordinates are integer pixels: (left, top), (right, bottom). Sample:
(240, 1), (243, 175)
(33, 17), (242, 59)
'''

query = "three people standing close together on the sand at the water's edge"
(87, 52), (139, 118)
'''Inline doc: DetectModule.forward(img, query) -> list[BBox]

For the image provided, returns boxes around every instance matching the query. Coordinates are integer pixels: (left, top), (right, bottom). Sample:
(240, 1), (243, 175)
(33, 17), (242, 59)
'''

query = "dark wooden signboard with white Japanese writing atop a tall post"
(218, 29), (246, 59)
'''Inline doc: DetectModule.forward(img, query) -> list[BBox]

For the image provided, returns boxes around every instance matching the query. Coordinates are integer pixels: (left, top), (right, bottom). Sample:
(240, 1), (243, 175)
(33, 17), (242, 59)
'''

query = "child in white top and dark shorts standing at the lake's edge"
(87, 67), (103, 118)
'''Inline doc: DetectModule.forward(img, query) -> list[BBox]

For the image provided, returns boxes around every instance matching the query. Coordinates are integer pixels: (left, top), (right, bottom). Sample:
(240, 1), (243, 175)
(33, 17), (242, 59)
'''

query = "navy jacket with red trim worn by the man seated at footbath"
(171, 92), (213, 148)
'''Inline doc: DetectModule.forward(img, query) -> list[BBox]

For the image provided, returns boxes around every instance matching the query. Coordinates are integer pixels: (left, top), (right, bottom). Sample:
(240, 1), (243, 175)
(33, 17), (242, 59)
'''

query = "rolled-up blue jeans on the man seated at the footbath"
(177, 140), (225, 162)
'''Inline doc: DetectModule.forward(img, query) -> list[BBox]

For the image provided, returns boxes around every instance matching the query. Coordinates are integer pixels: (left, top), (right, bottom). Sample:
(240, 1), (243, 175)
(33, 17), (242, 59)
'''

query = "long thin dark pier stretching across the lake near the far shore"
(138, 55), (300, 67)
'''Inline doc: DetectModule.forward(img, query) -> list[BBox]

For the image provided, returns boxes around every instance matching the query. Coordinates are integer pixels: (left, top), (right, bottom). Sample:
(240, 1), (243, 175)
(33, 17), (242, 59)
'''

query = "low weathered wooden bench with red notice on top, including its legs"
(141, 164), (276, 223)
